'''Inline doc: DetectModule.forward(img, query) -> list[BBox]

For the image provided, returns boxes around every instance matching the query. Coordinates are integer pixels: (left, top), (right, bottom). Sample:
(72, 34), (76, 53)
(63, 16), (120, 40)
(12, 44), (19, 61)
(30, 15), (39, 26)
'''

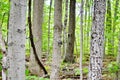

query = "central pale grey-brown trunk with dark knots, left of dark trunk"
(50, 0), (62, 80)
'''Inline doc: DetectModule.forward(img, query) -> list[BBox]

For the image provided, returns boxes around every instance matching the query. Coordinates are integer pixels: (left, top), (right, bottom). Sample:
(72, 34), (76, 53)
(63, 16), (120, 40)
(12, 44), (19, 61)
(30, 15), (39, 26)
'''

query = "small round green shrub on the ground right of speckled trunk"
(107, 62), (120, 73)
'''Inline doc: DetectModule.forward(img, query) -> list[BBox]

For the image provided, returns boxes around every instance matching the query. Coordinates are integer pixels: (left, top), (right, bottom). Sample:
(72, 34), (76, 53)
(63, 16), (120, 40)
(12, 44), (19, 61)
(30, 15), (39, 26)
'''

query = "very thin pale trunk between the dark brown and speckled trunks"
(80, 0), (84, 80)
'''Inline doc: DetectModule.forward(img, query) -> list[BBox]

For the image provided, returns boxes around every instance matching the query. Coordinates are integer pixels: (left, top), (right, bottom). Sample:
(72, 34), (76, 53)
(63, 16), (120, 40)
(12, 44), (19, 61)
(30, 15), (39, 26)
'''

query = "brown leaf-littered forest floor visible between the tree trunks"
(0, 54), (117, 80)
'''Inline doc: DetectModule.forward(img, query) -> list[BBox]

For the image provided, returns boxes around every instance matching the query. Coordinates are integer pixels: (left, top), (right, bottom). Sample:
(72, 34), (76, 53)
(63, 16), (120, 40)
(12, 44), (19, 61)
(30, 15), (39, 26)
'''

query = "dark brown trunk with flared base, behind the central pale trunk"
(64, 0), (76, 62)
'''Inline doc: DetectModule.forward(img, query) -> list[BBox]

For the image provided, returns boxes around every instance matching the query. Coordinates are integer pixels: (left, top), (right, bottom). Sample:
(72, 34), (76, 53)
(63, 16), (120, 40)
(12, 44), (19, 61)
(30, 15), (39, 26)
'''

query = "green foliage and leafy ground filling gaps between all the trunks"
(0, 0), (120, 80)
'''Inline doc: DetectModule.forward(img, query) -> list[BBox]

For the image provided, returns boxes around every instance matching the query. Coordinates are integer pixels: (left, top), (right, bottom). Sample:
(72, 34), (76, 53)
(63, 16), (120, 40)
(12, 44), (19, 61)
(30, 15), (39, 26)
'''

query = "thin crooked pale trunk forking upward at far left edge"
(0, 3), (10, 80)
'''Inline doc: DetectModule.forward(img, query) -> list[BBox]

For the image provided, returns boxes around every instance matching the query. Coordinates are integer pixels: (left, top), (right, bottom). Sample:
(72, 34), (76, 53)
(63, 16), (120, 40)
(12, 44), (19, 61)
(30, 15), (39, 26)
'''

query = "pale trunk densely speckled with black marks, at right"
(88, 0), (106, 80)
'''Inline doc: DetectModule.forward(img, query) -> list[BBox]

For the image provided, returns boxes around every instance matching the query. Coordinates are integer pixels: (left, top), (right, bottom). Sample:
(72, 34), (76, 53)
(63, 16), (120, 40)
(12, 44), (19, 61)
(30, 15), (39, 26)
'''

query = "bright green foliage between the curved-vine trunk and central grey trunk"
(42, 3), (54, 53)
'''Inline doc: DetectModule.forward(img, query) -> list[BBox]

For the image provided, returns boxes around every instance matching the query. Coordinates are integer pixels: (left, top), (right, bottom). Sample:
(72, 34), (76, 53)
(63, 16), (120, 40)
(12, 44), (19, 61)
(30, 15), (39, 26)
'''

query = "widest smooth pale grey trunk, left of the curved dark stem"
(7, 0), (27, 80)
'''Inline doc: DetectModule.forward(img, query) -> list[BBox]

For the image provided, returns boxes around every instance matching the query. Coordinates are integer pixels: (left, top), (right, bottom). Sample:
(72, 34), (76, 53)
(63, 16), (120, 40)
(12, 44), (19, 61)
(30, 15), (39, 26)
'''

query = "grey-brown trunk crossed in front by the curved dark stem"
(29, 0), (44, 76)
